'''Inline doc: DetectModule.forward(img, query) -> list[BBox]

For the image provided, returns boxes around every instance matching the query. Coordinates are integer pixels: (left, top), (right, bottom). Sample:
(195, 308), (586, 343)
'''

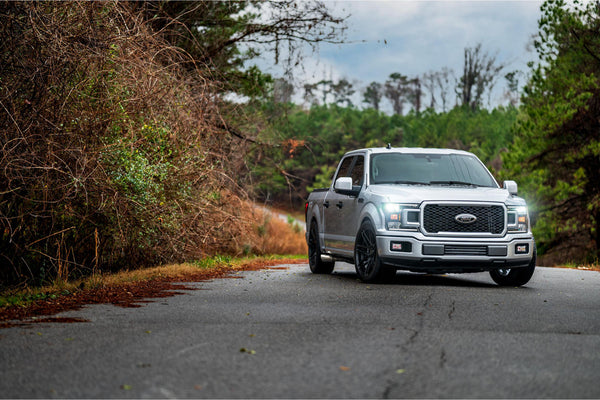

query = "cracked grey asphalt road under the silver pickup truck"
(0, 264), (600, 398)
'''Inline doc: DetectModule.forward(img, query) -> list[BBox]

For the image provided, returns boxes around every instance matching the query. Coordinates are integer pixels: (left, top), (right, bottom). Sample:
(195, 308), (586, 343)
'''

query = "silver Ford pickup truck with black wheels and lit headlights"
(305, 145), (536, 286)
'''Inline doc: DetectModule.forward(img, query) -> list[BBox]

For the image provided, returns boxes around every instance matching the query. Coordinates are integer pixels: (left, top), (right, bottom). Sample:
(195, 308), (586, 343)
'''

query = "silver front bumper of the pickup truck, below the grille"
(377, 235), (535, 273)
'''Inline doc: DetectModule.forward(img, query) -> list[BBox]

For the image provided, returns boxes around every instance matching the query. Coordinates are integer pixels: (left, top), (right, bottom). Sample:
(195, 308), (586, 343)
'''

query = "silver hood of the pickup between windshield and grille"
(368, 185), (524, 204)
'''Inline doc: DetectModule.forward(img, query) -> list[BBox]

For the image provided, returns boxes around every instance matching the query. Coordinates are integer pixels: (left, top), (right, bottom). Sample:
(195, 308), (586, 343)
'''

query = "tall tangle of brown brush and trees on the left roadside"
(0, 1), (318, 289)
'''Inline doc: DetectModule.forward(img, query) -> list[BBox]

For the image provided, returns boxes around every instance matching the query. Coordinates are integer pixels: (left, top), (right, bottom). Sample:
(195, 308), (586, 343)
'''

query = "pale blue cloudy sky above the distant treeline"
(253, 0), (542, 107)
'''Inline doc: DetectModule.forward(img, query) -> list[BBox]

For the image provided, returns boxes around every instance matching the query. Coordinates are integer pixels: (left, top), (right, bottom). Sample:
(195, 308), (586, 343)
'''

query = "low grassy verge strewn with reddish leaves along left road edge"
(0, 256), (306, 328)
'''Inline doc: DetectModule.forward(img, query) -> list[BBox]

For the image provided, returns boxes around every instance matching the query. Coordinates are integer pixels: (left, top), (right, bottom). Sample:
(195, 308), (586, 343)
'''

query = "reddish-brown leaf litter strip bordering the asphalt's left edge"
(0, 260), (306, 329)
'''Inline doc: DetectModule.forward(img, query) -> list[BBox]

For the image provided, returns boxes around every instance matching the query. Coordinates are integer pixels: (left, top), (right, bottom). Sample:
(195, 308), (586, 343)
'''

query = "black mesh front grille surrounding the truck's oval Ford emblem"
(423, 204), (504, 235)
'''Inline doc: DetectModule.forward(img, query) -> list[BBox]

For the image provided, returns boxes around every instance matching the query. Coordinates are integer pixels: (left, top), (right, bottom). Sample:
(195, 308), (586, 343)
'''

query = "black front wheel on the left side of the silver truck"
(354, 221), (396, 283)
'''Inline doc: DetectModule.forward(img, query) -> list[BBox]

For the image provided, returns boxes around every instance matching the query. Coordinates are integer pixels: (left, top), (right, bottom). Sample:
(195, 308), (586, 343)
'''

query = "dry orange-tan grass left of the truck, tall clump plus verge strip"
(0, 195), (307, 307)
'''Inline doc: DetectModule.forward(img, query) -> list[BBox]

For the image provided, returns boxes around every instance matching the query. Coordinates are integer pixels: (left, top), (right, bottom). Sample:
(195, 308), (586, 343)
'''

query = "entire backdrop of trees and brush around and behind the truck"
(0, 0), (600, 286)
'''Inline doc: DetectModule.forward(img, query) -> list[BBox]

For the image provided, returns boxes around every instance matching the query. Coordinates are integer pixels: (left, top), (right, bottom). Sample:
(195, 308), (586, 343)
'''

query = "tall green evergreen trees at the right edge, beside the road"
(504, 1), (600, 264)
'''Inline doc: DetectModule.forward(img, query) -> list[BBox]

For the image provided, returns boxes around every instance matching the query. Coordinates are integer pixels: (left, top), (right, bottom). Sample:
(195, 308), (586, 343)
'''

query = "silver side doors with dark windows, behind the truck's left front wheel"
(324, 155), (365, 256)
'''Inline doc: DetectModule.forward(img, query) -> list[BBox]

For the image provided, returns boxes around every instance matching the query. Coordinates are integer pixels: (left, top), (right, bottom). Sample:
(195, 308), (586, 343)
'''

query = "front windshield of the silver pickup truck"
(370, 153), (498, 187)
